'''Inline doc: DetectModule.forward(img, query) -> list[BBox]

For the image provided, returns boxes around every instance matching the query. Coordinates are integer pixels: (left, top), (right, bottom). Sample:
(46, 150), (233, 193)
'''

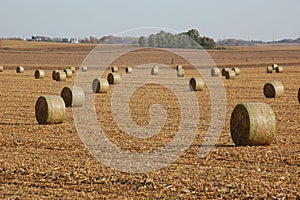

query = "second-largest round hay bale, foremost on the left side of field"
(35, 96), (66, 124)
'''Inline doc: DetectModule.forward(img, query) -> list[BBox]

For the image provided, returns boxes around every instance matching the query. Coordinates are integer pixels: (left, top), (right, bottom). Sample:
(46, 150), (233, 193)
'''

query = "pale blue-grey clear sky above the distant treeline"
(0, 0), (300, 41)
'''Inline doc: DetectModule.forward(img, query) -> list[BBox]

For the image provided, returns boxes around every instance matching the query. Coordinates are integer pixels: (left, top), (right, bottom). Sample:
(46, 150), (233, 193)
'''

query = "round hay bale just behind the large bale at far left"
(60, 86), (85, 107)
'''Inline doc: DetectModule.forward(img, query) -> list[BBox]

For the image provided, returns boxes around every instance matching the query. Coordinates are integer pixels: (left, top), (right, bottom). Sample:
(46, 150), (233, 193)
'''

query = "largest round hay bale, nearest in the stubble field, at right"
(230, 102), (276, 146)
